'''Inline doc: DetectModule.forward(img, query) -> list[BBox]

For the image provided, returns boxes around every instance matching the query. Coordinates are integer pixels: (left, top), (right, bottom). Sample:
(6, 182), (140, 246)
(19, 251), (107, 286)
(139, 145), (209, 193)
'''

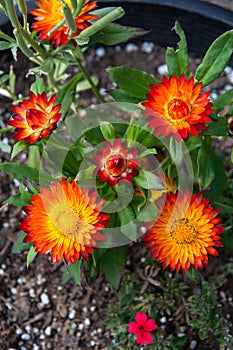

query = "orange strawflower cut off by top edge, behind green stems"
(31, 0), (99, 47)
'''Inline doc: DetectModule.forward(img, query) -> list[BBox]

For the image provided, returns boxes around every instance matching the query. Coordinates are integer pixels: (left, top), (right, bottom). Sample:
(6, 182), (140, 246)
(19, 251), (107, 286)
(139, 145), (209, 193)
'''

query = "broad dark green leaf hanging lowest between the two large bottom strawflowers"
(100, 245), (128, 290)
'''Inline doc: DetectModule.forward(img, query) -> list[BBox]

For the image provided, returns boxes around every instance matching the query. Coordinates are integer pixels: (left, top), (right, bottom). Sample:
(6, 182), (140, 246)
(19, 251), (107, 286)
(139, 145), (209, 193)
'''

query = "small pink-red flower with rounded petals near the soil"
(128, 312), (158, 345)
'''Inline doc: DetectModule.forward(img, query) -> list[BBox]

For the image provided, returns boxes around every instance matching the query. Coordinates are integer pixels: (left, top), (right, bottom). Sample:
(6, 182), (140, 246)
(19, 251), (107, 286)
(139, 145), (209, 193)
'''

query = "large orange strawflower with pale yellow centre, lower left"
(20, 179), (109, 264)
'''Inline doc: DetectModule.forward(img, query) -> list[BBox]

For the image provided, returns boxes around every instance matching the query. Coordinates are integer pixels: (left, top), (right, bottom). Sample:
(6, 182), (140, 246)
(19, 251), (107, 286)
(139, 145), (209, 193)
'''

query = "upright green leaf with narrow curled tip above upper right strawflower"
(166, 22), (189, 76)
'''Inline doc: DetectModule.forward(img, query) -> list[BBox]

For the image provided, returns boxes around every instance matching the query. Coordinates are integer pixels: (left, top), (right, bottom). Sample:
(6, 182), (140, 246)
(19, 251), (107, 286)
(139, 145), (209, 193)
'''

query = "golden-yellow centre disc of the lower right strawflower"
(169, 219), (197, 244)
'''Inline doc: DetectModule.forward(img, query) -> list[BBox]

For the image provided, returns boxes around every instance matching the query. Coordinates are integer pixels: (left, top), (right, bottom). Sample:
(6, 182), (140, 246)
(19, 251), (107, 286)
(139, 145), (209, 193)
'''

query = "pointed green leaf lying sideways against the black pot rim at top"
(89, 23), (147, 45)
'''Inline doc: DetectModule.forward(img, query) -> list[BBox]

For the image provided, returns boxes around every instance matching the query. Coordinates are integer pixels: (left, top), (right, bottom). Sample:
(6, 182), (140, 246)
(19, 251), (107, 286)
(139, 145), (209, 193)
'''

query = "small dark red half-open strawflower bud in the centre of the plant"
(93, 137), (139, 187)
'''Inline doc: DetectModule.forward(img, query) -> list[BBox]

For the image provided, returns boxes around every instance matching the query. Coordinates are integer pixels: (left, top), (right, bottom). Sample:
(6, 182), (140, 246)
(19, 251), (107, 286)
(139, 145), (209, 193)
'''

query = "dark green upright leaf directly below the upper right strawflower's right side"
(197, 137), (215, 188)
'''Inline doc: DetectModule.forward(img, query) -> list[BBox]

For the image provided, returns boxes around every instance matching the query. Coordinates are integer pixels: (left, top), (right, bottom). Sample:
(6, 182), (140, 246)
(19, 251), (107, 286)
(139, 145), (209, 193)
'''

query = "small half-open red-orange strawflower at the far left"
(8, 92), (62, 143)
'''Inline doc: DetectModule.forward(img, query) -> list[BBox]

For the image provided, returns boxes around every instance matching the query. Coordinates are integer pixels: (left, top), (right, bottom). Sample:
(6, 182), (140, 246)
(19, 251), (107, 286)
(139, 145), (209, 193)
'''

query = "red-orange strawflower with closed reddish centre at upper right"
(142, 74), (213, 141)
